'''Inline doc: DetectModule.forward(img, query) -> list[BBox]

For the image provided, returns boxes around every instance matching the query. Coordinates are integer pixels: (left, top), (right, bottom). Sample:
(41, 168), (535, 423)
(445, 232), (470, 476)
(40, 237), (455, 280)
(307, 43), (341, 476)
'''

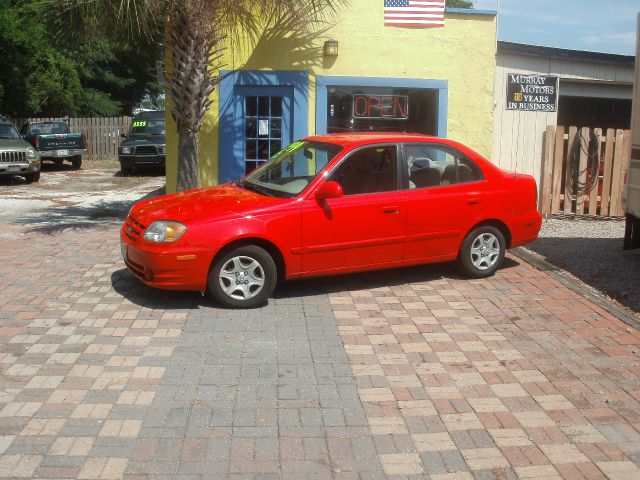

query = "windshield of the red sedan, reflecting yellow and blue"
(238, 141), (342, 197)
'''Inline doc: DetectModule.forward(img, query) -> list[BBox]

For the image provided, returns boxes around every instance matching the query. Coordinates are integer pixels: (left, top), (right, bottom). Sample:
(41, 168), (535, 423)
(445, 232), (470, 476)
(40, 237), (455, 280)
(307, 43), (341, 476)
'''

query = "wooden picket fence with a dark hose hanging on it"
(540, 125), (631, 217)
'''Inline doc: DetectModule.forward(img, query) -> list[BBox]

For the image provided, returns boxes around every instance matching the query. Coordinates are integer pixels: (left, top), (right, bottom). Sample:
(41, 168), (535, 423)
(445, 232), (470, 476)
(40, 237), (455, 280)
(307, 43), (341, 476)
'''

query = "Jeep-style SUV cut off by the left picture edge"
(0, 121), (40, 183)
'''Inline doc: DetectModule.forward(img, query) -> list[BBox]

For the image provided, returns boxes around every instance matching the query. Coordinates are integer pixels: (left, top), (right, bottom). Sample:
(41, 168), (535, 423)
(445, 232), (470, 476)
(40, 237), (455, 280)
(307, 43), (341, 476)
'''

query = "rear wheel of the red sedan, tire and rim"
(458, 225), (506, 278)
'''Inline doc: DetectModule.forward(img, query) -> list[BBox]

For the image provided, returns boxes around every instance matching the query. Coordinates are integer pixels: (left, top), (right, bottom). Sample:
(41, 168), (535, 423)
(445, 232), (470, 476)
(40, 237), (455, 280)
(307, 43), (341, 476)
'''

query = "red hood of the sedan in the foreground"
(131, 184), (288, 226)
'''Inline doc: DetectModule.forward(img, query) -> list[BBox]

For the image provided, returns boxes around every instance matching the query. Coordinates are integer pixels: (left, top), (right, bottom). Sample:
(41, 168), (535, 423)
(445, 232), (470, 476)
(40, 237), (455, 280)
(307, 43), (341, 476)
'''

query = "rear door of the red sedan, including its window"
(403, 144), (486, 260)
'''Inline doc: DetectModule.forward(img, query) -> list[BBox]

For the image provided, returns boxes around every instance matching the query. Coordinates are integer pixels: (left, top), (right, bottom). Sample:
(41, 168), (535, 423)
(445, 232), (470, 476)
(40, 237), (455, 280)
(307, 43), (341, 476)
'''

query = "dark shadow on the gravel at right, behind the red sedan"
(527, 237), (640, 312)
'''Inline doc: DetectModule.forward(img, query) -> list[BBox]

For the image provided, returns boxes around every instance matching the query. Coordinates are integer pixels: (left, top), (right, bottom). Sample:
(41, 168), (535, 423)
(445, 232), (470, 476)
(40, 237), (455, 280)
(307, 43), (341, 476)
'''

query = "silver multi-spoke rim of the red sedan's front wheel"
(218, 255), (265, 300)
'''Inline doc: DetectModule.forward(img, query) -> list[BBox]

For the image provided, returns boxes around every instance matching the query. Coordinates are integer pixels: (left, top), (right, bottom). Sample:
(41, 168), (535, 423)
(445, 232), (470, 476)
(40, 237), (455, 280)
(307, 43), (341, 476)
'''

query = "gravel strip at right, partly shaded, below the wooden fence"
(527, 218), (640, 314)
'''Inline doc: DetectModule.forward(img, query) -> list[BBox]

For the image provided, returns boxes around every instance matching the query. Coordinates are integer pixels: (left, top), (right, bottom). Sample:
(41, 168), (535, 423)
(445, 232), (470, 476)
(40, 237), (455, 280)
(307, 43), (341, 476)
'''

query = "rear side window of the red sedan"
(405, 145), (482, 189)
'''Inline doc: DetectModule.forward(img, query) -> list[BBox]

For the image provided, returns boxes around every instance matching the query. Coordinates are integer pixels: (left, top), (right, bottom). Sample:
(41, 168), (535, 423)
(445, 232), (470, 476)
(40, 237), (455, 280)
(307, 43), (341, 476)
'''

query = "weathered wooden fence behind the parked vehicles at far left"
(11, 117), (131, 160)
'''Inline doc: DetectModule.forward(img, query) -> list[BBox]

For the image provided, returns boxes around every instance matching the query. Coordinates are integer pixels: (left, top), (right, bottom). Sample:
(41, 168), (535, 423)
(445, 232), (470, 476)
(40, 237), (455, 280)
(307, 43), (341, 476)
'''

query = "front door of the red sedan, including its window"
(302, 145), (407, 272)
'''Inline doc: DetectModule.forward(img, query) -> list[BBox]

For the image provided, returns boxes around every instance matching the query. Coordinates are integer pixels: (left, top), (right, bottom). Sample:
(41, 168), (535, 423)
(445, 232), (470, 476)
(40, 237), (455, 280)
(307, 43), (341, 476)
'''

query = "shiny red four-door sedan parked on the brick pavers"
(121, 133), (542, 308)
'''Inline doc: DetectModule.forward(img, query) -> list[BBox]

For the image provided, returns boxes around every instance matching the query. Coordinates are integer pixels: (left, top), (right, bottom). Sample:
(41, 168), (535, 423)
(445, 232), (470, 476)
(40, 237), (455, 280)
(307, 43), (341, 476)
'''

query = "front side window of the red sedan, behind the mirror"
(329, 146), (398, 195)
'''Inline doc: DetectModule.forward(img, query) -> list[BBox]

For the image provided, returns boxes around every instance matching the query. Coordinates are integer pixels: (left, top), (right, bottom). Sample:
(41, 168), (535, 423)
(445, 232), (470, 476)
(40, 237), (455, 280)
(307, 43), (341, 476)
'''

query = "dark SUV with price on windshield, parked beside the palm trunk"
(118, 111), (166, 175)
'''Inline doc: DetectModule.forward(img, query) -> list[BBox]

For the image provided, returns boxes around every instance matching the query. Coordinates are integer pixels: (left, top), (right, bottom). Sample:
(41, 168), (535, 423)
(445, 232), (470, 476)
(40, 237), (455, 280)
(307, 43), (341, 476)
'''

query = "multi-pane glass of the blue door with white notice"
(244, 95), (282, 174)
